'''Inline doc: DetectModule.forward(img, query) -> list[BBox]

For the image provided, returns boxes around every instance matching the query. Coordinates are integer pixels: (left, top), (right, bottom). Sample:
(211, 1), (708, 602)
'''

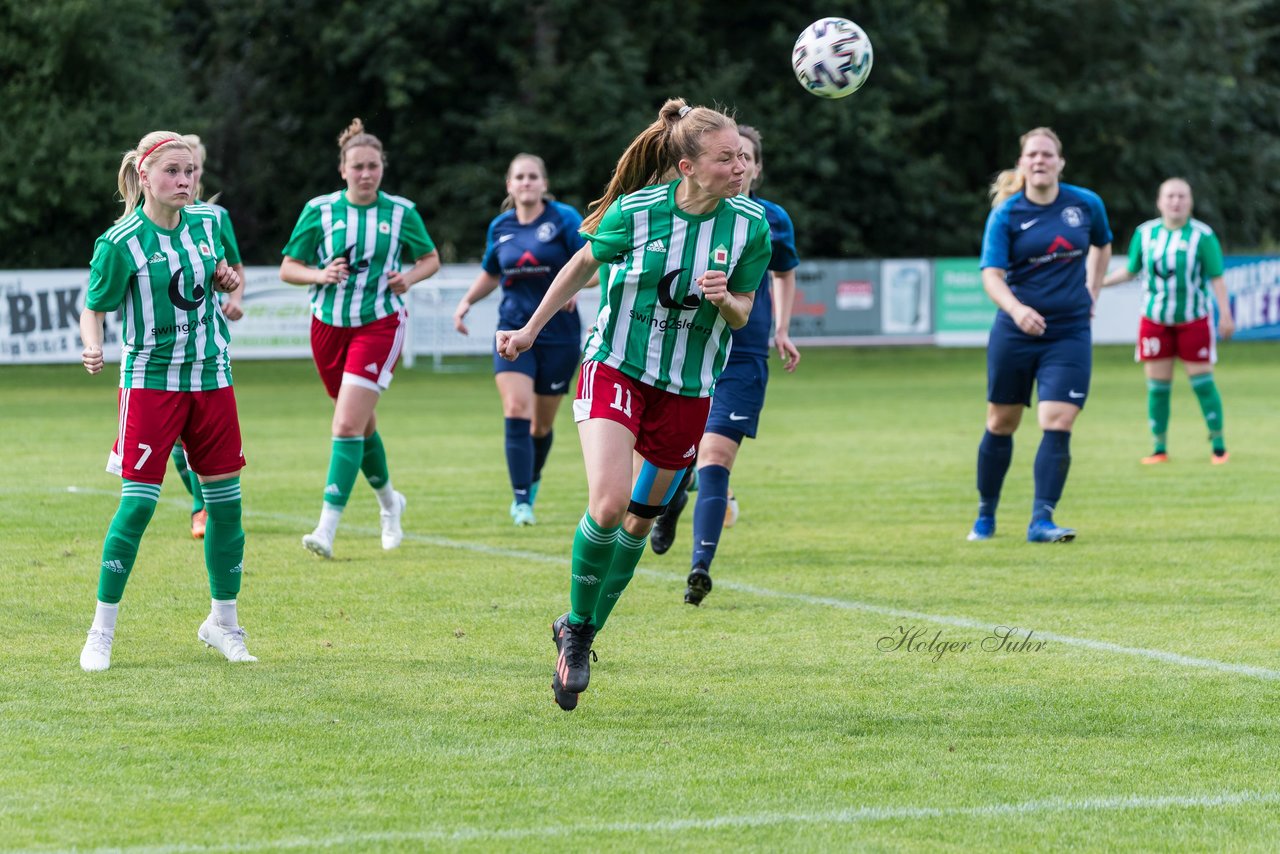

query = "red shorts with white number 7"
(106, 387), (244, 484)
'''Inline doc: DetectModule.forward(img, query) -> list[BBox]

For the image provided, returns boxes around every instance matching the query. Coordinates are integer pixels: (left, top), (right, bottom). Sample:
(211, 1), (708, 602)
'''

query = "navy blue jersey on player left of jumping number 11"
(480, 201), (582, 347)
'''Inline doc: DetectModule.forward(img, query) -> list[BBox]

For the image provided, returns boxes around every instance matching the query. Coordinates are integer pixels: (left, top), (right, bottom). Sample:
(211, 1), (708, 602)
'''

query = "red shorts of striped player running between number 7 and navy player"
(311, 309), (408, 399)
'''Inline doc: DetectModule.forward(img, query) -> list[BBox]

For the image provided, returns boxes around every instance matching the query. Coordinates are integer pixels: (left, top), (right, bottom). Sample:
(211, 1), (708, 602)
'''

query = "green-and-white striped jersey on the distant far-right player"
(1129, 219), (1222, 326)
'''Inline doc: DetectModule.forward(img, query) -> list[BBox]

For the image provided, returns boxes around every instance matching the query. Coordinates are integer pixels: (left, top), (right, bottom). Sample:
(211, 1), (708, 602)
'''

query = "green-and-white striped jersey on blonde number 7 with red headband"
(84, 204), (232, 392)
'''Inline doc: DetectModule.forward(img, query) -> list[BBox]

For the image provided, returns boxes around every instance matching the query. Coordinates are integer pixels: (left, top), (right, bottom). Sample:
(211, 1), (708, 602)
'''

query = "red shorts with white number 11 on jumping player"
(573, 361), (712, 471)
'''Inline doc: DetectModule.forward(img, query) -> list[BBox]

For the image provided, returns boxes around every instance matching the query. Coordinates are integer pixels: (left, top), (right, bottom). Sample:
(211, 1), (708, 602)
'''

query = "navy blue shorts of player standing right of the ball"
(987, 324), (1093, 408)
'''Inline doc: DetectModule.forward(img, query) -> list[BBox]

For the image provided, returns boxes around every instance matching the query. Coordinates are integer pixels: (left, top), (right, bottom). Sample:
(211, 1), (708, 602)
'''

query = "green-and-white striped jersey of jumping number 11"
(582, 181), (772, 397)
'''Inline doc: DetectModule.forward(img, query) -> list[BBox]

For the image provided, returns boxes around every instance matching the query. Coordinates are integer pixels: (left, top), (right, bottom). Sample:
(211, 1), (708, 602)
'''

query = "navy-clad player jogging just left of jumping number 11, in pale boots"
(453, 154), (582, 526)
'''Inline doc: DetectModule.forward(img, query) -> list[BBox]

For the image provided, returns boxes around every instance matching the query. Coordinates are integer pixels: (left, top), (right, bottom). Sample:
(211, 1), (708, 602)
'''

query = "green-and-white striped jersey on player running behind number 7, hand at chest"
(284, 189), (435, 326)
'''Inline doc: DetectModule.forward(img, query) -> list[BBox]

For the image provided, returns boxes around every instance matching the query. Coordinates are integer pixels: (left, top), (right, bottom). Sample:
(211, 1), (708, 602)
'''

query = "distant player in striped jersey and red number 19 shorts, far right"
(1102, 178), (1235, 465)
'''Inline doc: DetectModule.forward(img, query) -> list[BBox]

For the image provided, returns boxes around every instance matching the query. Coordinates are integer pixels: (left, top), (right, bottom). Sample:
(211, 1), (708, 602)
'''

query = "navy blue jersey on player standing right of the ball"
(982, 184), (1111, 335)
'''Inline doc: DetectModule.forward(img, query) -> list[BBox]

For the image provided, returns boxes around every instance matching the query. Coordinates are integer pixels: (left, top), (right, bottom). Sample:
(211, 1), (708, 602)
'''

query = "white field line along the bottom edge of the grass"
(12, 791), (1280, 854)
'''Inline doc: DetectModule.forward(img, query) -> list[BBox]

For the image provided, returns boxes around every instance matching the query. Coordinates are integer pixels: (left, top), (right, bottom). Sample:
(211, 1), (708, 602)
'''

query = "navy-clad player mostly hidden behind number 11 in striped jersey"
(649, 124), (800, 606)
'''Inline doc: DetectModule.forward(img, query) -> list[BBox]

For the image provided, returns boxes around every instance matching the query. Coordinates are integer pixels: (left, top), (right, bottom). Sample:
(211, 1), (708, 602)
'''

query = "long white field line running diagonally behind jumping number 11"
(57, 487), (1280, 681)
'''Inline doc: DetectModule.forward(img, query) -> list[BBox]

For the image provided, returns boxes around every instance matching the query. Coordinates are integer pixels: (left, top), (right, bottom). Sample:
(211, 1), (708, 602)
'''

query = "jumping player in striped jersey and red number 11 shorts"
(498, 99), (769, 711)
